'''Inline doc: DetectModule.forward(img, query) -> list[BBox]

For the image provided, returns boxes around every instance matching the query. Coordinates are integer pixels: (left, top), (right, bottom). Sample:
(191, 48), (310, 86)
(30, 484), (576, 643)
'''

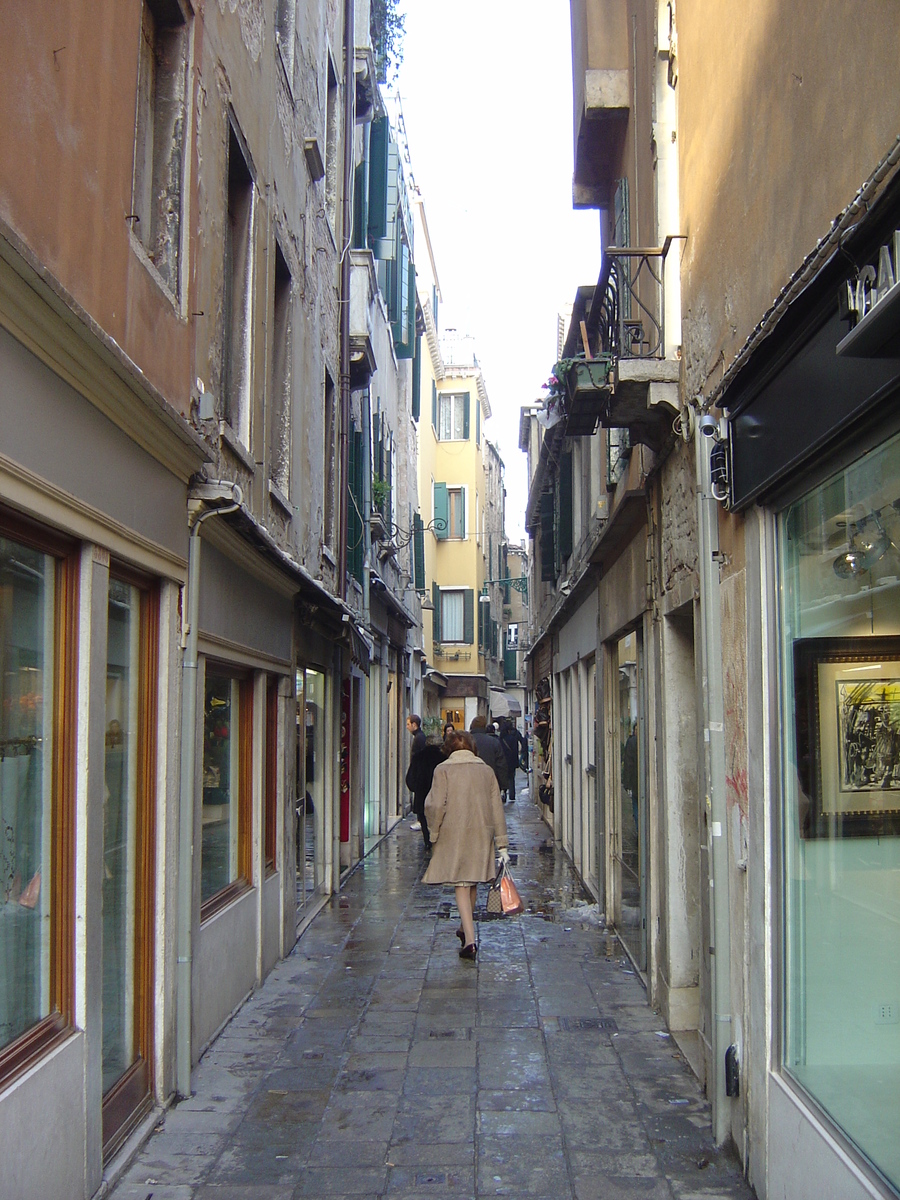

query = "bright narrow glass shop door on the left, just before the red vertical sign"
(296, 670), (328, 914)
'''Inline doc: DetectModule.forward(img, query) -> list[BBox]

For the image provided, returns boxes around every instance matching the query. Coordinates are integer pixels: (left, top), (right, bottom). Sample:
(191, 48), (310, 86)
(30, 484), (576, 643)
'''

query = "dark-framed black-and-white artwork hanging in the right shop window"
(793, 637), (900, 838)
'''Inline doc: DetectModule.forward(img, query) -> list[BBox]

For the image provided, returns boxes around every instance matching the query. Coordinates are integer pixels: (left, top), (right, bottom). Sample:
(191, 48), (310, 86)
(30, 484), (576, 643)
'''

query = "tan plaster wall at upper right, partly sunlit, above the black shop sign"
(677, 0), (900, 395)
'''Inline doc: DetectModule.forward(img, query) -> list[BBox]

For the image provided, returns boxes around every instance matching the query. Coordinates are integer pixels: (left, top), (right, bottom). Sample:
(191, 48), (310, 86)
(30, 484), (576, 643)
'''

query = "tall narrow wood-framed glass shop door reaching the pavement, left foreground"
(101, 577), (158, 1159)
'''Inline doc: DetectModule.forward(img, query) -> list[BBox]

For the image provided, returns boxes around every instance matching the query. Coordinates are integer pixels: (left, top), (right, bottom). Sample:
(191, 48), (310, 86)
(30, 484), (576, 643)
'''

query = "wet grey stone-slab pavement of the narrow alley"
(110, 773), (754, 1200)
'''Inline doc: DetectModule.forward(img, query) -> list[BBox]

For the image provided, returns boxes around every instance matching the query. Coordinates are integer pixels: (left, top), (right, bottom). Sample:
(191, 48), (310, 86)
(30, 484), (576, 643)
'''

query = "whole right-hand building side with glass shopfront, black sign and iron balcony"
(522, 0), (900, 1200)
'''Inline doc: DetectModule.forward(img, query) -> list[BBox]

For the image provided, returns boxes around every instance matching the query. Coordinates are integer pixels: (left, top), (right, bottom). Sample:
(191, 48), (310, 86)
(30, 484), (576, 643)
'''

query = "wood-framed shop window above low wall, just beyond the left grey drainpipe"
(200, 665), (253, 918)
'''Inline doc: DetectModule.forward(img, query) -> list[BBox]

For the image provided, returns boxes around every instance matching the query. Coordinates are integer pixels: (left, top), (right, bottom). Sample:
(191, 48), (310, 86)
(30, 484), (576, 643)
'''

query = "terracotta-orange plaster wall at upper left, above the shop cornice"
(0, 0), (193, 413)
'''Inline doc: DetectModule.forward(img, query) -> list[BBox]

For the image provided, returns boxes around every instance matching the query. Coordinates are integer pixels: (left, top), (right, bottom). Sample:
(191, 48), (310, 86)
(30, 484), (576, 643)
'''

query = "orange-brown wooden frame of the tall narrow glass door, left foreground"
(102, 563), (160, 1162)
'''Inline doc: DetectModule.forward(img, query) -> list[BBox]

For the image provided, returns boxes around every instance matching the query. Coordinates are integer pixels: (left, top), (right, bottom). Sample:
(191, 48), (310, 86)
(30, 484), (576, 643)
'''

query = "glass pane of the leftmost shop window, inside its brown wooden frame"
(0, 538), (56, 1050)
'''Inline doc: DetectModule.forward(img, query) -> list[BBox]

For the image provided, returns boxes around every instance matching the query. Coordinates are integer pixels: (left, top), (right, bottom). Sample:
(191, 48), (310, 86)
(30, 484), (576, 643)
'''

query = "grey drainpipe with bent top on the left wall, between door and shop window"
(175, 488), (240, 1098)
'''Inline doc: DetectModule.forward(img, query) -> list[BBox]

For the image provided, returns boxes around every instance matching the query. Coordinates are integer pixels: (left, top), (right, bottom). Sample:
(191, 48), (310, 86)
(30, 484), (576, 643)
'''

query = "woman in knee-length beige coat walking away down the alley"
(424, 730), (509, 959)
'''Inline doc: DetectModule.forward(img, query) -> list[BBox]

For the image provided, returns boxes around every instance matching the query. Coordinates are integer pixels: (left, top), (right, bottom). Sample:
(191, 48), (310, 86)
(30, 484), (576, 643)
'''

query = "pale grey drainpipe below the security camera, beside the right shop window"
(694, 422), (732, 1146)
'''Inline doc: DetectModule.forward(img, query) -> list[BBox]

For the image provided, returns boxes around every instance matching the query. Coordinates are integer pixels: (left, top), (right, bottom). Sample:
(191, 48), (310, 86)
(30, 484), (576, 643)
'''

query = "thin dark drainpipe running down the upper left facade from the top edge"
(337, 0), (356, 599)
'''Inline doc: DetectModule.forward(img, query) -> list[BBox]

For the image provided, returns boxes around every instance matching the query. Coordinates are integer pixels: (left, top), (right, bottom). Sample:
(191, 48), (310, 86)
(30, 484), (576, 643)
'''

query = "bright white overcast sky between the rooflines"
(394, 0), (600, 541)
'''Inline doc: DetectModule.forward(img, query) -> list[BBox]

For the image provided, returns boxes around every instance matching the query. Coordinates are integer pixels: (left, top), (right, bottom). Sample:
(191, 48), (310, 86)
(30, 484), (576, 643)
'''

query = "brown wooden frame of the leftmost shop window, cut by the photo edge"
(0, 505), (80, 1088)
